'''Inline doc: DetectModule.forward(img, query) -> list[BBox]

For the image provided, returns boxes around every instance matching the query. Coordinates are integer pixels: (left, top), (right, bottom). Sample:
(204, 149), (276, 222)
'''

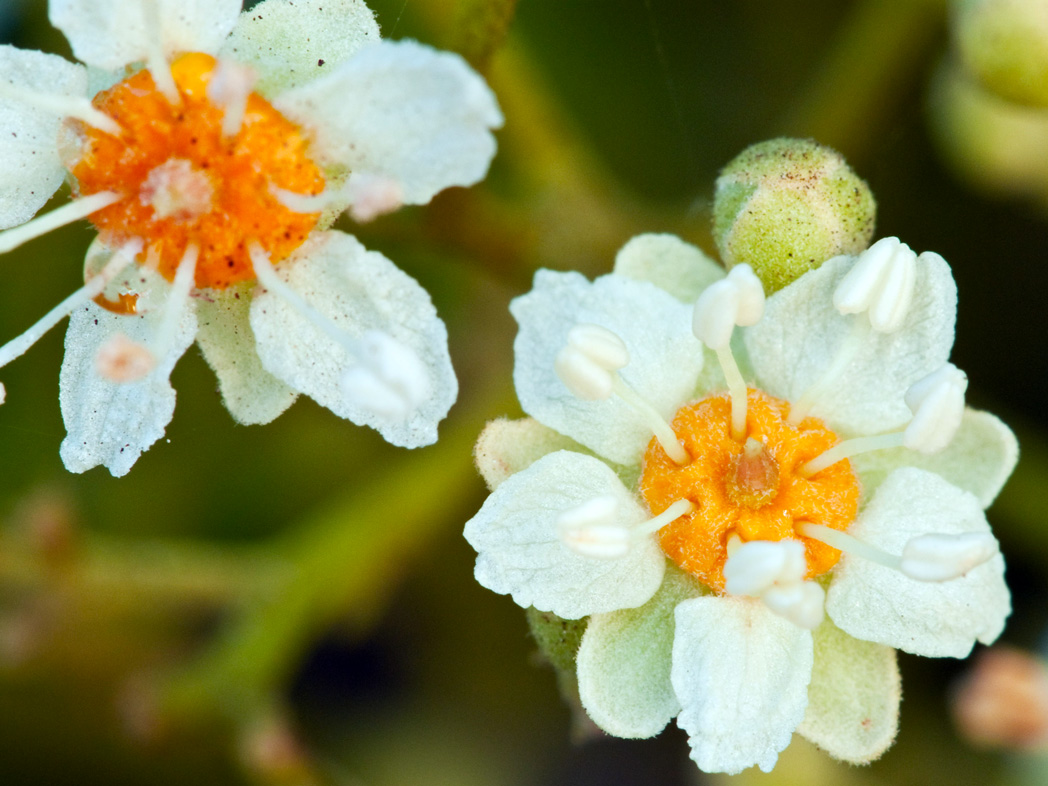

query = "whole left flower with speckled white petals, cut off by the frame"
(0, 0), (502, 475)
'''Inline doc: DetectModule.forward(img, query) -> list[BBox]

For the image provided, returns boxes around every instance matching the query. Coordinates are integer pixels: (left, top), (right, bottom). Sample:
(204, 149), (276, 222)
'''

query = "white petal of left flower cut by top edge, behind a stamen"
(48, 0), (241, 70)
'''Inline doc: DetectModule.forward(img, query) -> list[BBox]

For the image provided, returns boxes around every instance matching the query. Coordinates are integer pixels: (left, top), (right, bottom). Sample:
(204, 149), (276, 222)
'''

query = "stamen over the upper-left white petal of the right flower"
(553, 324), (691, 466)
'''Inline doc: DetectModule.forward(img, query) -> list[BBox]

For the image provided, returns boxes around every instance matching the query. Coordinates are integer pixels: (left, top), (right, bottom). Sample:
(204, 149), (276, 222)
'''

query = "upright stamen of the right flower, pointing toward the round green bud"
(692, 264), (764, 442)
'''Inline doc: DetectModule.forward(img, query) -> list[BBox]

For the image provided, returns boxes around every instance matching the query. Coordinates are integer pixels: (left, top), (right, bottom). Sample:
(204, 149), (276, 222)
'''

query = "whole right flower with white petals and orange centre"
(465, 236), (1017, 772)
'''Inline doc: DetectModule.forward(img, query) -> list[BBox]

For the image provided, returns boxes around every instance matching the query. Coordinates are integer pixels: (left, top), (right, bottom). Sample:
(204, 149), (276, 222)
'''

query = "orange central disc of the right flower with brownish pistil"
(640, 389), (859, 591)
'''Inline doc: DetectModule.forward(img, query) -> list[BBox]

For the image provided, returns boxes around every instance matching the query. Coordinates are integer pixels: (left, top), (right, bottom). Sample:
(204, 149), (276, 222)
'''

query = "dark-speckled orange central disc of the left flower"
(70, 53), (324, 289)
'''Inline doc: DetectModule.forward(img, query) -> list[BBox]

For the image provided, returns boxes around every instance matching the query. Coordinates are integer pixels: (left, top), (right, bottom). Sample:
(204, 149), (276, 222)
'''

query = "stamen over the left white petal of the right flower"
(556, 496), (695, 560)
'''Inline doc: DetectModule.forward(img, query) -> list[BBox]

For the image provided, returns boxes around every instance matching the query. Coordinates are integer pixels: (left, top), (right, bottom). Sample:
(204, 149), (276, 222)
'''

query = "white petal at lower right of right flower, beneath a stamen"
(826, 467), (1011, 658)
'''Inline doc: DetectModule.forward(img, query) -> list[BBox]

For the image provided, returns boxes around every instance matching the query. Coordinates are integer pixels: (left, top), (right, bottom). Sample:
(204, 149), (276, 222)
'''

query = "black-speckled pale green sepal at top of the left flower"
(219, 0), (378, 95)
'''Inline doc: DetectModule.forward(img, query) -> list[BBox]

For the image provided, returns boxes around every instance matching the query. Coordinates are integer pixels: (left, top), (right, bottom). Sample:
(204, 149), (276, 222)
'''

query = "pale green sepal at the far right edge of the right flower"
(851, 409), (1019, 508)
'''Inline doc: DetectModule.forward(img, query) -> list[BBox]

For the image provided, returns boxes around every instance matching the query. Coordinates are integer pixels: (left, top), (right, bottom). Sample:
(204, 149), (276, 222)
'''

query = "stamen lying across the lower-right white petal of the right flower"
(794, 521), (998, 582)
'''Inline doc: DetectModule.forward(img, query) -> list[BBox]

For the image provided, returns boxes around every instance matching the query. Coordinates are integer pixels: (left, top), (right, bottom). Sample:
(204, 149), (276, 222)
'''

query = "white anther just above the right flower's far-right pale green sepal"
(902, 363), (968, 453)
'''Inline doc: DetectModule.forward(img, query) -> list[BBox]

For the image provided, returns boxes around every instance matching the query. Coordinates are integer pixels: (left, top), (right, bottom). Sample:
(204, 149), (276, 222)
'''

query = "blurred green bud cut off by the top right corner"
(953, 0), (1048, 107)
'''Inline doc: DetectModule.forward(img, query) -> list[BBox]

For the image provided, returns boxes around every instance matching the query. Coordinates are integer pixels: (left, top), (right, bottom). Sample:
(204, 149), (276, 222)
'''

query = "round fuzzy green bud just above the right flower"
(714, 138), (876, 294)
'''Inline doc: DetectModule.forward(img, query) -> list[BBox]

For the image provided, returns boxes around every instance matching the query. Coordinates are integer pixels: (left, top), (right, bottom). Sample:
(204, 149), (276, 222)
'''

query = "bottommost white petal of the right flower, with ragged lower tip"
(673, 597), (812, 774)
